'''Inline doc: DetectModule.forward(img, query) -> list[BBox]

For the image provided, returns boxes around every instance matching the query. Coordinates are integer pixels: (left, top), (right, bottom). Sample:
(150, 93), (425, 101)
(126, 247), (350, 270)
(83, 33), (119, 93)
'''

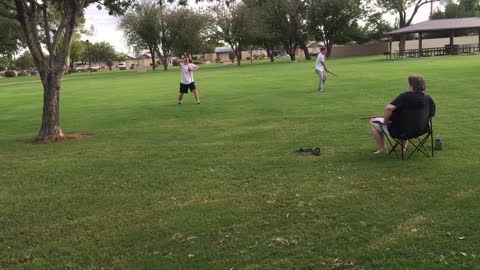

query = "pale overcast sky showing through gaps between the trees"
(83, 1), (442, 54)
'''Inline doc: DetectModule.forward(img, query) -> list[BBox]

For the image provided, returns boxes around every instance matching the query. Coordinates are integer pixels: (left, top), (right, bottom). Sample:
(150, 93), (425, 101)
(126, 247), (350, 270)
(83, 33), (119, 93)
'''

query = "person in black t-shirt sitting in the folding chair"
(370, 76), (435, 154)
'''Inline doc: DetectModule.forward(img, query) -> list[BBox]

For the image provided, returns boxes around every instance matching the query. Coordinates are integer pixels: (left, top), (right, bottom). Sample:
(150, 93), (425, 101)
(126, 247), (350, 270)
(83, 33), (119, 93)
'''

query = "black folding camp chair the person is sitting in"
(382, 96), (435, 160)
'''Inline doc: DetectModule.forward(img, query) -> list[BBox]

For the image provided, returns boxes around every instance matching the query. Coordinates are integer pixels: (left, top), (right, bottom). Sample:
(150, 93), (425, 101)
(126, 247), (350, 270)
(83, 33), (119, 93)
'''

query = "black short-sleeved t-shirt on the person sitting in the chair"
(388, 91), (436, 137)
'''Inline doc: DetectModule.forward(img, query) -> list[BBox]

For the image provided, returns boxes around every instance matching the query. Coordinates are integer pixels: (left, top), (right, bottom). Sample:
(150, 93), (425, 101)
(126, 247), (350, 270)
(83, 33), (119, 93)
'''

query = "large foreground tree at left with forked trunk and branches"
(0, 0), (132, 142)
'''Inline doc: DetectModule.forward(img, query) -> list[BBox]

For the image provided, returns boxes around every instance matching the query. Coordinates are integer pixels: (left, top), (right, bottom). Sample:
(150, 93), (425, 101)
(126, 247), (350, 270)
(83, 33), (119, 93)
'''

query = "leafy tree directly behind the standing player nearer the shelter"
(307, 0), (364, 56)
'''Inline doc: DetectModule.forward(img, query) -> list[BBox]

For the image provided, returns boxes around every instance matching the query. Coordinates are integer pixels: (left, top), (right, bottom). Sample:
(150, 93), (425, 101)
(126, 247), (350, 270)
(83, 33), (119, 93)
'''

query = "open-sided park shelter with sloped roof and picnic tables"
(387, 17), (480, 58)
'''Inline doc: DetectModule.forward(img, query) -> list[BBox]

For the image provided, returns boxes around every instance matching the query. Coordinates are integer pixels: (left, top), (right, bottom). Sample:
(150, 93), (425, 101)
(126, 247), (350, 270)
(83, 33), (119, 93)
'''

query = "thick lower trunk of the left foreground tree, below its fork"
(36, 71), (63, 142)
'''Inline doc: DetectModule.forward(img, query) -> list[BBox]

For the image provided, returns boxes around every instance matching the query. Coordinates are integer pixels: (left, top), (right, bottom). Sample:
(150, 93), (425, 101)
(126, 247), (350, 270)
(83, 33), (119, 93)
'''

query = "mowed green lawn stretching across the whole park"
(0, 56), (480, 269)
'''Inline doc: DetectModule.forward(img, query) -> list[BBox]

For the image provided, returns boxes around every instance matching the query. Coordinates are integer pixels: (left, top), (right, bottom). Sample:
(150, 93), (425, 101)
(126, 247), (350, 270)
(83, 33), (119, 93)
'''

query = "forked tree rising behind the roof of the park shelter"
(376, 0), (441, 51)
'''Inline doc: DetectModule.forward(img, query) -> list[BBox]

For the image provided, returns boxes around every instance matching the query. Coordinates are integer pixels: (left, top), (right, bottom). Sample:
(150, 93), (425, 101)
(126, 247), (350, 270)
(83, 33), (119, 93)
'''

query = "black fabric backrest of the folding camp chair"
(392, 96), (433, 139)
